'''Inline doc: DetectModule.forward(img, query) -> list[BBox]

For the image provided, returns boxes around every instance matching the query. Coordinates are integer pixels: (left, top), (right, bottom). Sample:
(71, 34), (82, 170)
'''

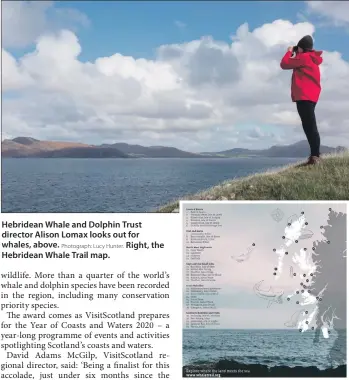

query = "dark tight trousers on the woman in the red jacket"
(297, 100), (320, 157)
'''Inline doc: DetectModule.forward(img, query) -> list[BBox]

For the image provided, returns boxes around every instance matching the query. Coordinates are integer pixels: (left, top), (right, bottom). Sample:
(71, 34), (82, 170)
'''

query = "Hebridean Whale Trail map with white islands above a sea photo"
(182, 202), (347, 377)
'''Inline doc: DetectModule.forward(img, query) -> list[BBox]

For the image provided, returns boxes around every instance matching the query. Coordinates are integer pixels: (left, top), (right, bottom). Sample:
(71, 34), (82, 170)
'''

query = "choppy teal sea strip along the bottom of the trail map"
(183, 329), (347, 369)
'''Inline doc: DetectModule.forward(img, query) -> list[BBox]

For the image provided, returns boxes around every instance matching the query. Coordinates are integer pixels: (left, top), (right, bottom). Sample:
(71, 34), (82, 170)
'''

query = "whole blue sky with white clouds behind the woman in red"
(2, 1), (349, 152)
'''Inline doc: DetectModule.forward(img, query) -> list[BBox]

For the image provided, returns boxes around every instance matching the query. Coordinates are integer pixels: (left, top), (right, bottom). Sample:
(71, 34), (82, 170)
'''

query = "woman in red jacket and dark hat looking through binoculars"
(280, 36), (322, 165)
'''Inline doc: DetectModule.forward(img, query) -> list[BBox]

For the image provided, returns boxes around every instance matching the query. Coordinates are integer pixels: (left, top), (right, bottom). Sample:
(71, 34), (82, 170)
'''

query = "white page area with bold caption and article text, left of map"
(0, 214), (182, 380)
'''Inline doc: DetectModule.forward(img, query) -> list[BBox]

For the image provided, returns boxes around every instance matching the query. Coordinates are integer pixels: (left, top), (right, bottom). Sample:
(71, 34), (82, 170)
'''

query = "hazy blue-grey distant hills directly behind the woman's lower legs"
(203, 141), (347, 158)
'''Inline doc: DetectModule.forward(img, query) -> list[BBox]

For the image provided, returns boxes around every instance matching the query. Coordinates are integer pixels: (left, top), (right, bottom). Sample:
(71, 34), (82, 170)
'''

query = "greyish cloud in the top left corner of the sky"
(2, 1), (89, 48)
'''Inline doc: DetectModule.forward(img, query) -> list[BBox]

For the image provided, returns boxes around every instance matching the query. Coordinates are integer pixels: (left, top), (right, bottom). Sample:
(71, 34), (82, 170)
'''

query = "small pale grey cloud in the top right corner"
(306, 1), (349, 26)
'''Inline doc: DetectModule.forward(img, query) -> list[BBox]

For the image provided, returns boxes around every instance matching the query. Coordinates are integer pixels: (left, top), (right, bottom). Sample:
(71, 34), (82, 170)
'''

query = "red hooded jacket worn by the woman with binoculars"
(280, 50), (322, 103)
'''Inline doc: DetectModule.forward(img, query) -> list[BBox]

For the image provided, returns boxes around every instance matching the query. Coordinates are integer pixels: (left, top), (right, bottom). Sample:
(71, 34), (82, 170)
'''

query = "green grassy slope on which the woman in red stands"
(156, 152), (349, 213)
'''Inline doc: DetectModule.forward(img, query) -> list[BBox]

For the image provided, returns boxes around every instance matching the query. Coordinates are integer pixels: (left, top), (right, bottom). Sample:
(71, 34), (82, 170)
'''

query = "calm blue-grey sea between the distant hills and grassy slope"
(2, 158), (300, 213)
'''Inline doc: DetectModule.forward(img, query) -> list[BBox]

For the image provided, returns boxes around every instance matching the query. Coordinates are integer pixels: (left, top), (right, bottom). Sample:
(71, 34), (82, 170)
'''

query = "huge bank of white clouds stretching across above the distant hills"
(3, 15), (349, 151)
